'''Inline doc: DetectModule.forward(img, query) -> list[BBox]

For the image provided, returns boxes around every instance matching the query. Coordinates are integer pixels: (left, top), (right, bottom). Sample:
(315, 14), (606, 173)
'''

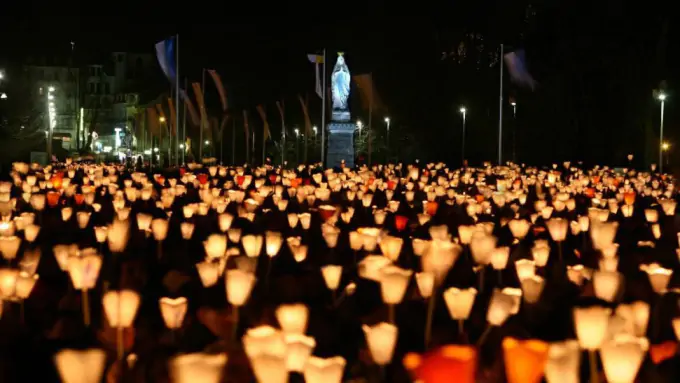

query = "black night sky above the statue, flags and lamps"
(0, 0), (680, 165)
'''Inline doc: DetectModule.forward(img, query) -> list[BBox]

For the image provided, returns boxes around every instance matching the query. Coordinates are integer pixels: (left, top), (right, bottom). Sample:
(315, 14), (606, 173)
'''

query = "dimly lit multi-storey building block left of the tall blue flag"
(23, 52), (155, 153)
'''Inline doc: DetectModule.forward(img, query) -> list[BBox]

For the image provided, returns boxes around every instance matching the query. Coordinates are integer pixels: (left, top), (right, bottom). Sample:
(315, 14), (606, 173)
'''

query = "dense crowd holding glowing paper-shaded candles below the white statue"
(0, 160), (680, 383)
